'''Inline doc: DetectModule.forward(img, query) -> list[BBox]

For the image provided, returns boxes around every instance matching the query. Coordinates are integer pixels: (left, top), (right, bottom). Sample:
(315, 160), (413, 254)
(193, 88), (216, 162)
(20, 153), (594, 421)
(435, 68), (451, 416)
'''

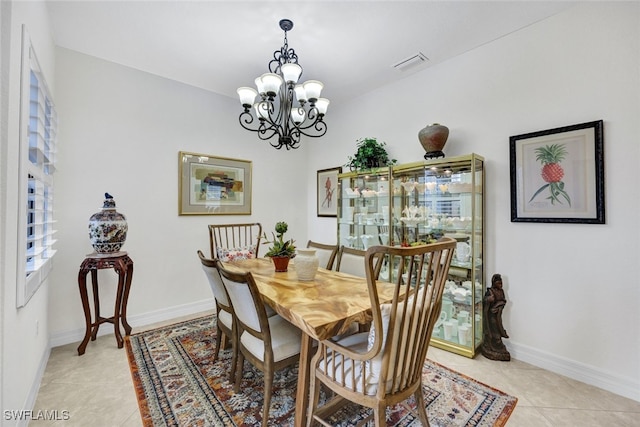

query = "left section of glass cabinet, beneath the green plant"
(338, 167), (391, 254)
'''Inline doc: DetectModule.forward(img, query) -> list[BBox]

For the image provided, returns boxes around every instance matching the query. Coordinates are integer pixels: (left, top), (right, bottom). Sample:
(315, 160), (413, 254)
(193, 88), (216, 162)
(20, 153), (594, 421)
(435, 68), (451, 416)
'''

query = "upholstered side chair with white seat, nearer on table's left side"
(216, 260), (302, 427)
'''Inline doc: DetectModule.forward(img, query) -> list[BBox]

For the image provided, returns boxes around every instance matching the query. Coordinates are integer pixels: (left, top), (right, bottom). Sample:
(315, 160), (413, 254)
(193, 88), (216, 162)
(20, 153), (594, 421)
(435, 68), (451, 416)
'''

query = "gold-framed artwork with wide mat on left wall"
(178, 151), (252, 215)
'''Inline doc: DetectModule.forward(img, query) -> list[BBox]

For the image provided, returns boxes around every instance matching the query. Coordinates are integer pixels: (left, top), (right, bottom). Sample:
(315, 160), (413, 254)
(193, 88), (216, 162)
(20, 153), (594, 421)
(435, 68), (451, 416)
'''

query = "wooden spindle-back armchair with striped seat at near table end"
(307, 237), (456, 427)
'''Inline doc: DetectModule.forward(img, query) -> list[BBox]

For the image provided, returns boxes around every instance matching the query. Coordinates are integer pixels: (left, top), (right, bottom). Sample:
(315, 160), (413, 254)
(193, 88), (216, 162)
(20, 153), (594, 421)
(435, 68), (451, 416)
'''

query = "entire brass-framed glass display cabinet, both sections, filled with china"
(338, 154), (485, 357)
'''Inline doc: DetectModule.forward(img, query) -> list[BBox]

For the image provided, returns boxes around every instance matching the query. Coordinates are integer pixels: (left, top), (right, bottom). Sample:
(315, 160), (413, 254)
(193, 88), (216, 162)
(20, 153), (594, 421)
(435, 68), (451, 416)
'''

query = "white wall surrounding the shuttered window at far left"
(0, 2), (55, 423)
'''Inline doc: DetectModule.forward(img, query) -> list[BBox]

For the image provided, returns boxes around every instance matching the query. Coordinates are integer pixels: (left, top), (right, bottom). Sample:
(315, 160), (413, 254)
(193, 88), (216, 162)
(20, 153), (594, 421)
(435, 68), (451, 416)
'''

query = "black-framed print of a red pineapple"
(509, 120), (605, 224)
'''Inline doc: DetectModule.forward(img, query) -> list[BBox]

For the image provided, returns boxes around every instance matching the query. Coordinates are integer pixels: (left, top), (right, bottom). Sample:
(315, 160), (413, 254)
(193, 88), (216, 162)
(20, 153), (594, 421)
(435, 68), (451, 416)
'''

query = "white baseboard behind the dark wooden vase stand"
(45, 298), (215, 350)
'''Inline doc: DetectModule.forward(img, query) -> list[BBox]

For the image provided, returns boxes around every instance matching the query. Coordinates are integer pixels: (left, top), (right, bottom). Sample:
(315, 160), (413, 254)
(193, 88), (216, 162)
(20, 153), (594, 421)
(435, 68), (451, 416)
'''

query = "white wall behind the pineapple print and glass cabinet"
(309, 2), (640, 400)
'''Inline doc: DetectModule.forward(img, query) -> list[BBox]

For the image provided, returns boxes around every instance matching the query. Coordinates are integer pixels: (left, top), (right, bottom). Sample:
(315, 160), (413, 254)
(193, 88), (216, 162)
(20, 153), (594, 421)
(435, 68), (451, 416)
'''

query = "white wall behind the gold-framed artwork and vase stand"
(50, 49), (307, 340)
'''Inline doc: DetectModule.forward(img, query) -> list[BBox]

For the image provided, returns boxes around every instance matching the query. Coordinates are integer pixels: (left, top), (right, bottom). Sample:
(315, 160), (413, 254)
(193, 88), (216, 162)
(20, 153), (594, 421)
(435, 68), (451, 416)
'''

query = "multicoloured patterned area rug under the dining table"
(125, 316), (517, 427)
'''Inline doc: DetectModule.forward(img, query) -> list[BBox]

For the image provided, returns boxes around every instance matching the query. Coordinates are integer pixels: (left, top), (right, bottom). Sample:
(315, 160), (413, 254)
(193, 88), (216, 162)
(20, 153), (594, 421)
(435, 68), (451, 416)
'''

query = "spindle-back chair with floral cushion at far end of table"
(209, 222), (262, 262)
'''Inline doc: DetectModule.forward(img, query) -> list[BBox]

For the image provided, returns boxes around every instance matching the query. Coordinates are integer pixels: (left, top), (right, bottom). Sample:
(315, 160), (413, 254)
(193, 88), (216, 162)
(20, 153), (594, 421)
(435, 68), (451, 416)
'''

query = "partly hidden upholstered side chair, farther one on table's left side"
(198, 250), (238, 381)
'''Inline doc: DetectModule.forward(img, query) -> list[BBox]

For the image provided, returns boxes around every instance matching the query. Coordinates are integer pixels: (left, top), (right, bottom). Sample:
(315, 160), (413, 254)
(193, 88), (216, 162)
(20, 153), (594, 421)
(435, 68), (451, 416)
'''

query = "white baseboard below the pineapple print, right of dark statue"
(506, 341), (640, 402)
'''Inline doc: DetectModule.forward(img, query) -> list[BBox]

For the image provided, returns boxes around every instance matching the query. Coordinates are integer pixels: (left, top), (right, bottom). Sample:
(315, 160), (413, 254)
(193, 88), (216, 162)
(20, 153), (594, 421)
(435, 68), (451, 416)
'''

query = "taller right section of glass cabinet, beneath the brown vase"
(389, 154), (485, 357)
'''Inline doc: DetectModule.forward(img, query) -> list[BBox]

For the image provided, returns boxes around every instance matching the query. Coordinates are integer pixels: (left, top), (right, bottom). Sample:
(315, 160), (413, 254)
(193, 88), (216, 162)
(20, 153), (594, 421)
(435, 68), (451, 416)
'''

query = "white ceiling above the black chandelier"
(47, 0), (576, 103)
